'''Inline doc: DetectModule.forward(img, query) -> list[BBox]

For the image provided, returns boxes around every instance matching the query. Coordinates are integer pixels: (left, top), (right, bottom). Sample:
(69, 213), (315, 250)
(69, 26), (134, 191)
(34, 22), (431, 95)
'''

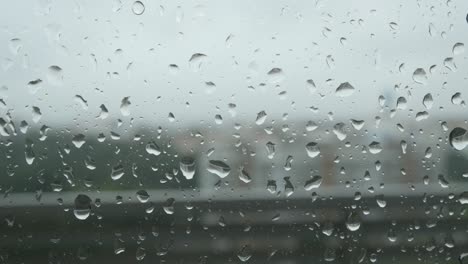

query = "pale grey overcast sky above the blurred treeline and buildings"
(0, 0), (468, 127)
